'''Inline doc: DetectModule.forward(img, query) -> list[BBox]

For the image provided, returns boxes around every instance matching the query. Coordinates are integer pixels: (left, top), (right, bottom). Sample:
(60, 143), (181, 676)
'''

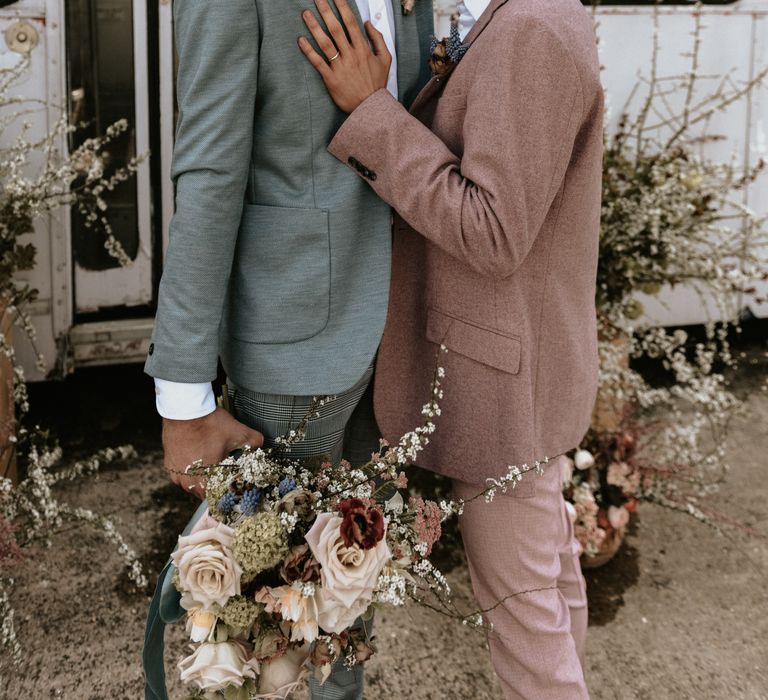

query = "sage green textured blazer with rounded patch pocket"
(145, 0), (433, 395)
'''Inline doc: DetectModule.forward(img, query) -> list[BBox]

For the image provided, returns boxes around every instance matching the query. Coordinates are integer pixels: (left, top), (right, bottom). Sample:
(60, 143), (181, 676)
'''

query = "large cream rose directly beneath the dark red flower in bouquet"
(306, 513), (392, 633)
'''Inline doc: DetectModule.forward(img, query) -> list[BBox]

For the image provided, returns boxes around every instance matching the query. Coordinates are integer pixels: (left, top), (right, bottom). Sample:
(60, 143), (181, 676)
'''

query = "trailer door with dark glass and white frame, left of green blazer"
(64, 0), (157, 318)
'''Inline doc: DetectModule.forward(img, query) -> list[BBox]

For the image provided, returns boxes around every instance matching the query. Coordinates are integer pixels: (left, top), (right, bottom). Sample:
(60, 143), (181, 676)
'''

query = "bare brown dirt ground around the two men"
(0, 330), (768, 700)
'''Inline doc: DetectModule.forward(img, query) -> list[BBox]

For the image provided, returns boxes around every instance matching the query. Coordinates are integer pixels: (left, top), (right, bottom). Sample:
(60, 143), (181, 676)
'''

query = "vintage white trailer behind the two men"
(0, 0), (768, 379)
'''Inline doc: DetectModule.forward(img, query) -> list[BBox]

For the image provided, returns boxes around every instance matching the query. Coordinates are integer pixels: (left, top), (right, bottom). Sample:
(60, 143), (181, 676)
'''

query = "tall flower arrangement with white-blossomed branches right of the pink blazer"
(565, 8), (768, 566)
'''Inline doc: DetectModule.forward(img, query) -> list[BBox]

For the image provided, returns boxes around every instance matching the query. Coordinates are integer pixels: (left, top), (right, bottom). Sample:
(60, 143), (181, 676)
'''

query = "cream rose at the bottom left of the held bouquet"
(179, 641), (259, 692)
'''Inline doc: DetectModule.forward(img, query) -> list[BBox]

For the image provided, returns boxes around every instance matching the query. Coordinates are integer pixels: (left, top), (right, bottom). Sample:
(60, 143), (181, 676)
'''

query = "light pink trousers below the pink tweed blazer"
(454, 457), (589, 700)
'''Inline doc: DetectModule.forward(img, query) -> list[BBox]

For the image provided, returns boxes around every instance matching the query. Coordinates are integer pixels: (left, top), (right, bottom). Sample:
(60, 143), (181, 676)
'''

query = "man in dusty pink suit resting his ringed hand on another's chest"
(299, 0), (603, 700)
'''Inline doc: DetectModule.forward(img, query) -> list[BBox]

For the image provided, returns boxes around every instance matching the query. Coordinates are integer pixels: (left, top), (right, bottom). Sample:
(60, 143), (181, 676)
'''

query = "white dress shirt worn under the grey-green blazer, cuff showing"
(155, 0), (400, 420)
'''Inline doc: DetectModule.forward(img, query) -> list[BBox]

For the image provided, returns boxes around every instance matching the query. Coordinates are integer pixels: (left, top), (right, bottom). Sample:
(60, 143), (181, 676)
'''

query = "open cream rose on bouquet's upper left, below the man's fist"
(172, 511), (243, 609)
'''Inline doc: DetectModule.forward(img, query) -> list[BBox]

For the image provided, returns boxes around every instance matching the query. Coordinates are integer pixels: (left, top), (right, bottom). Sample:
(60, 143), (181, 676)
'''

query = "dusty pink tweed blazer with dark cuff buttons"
(329, 0), (603, 483)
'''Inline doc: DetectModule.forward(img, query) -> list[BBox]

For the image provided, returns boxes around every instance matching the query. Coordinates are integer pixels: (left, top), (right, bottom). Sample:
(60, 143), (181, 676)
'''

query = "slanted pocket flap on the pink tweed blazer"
(427, 309), (522, 374)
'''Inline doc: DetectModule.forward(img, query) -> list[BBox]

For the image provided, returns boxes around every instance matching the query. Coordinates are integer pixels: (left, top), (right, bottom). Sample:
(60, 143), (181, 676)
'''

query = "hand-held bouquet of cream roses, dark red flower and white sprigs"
(172, 356), (462, 700)
